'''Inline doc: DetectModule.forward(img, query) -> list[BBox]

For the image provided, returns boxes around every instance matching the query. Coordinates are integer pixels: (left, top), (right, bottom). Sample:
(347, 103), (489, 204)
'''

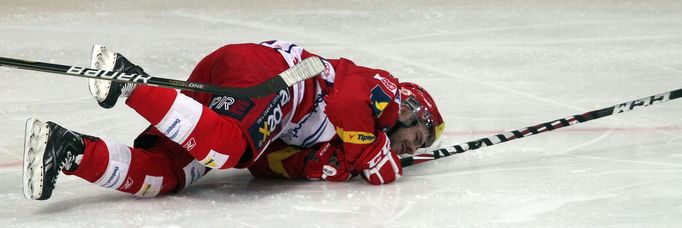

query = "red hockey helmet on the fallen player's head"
(399, 82), (445, 147)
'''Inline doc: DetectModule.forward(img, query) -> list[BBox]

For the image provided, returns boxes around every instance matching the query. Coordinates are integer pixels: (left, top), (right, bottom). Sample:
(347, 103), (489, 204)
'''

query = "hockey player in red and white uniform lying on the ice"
(23, 41), (444, 200)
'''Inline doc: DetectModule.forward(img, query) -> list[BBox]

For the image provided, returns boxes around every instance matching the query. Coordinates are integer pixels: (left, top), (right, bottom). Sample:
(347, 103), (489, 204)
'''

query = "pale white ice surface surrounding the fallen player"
(0, 0), (682, 228)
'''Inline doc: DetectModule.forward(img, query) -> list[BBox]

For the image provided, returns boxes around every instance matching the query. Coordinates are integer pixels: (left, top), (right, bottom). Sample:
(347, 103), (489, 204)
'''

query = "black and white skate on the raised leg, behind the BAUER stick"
(88, 44), (148, 108)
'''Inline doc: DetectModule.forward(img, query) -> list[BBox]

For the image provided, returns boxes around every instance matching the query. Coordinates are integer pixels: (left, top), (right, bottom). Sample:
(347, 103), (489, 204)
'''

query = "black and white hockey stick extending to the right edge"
(400, 89), (682, 167)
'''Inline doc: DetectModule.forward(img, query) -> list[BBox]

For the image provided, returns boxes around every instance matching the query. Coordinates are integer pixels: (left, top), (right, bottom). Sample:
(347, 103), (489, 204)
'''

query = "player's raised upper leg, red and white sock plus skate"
(90, 46), (251, 169)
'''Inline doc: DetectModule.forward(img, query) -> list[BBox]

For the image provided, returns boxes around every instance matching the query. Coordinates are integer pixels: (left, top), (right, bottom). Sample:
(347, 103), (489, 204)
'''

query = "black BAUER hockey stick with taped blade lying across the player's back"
(0, 56), (325, 98)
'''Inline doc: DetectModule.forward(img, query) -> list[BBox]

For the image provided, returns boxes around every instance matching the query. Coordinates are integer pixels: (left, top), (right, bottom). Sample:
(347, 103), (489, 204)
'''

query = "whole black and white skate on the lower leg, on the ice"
(23, 118), (90, 200)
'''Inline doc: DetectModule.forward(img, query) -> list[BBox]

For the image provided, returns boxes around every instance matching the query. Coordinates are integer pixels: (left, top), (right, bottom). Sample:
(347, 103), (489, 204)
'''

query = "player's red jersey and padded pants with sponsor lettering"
(183, 41), (400, 174)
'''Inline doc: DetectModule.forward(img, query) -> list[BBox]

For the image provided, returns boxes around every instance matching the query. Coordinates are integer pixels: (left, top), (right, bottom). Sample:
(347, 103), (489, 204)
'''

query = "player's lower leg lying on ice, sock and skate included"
(23, 120), (208, 200)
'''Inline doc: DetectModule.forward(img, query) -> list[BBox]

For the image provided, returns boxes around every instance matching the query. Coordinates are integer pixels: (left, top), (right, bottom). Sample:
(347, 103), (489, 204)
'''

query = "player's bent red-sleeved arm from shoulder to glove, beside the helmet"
(326, 67), (402, 185)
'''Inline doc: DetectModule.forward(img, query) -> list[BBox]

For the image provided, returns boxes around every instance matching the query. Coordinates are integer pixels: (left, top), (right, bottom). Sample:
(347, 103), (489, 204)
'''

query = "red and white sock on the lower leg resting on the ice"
(64, 139), (199, 197)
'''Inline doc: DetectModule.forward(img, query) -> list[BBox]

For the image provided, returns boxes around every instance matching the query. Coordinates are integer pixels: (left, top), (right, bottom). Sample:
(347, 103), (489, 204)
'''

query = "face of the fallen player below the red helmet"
(389, 124), (429, 155)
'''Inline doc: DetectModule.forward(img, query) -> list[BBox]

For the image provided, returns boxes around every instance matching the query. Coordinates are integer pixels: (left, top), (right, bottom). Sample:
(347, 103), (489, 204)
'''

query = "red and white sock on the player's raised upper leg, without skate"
(126, 86), (251, 169)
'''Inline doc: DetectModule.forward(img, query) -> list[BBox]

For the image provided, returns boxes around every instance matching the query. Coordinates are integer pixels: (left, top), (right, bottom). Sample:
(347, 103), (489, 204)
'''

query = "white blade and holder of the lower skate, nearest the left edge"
(22, 118), (49, 199)
